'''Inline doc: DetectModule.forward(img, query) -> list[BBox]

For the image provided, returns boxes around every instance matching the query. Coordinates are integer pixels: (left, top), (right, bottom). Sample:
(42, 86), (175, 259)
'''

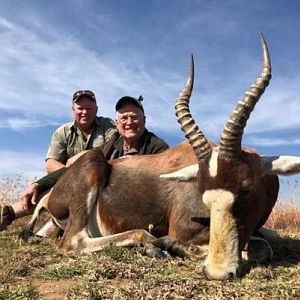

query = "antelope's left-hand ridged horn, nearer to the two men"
(175, 55), (212, 159)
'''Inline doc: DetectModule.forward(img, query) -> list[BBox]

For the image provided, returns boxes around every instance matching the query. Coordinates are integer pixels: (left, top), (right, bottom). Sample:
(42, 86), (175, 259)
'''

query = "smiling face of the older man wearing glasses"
(116, 103), (146, 141)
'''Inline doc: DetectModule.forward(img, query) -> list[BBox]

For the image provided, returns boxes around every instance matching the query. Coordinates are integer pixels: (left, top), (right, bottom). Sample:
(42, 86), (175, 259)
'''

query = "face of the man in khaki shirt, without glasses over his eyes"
(72, 96), (98, 129)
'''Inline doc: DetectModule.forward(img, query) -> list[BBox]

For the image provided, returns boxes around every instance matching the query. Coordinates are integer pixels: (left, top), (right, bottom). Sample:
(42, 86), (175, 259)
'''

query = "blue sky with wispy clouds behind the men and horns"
(0, 0), (300, 200)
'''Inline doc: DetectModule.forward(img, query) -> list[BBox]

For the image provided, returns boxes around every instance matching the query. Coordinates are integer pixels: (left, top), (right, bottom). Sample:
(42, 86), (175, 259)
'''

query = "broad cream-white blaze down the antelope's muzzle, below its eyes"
(202, 189), (239, 280)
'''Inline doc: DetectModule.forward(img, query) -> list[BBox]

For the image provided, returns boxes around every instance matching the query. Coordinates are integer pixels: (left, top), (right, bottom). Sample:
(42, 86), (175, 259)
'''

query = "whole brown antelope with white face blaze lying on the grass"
(22, 33), (300, 279)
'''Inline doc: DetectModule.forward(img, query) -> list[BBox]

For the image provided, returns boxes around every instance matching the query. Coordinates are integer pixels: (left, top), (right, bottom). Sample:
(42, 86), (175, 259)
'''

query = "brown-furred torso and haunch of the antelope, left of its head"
(33, 142), (209, 249)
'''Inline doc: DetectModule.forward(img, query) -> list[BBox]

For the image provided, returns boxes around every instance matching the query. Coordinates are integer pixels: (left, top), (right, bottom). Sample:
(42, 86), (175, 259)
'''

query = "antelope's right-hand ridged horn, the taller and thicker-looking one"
(219, 33), (272, 157)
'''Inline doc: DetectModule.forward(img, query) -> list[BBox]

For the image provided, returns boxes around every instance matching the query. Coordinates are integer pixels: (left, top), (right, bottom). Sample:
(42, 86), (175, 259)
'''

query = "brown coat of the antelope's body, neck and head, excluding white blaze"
(23, 133), (278, 276)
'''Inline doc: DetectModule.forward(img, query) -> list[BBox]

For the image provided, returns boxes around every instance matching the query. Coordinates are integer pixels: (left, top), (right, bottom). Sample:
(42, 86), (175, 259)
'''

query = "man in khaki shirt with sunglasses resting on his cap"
(0, 90), (117, 231)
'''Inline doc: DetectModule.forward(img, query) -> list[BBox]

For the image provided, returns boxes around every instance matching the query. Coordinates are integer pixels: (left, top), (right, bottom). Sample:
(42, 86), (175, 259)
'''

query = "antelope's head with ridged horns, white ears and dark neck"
(161, 34), (299, 280)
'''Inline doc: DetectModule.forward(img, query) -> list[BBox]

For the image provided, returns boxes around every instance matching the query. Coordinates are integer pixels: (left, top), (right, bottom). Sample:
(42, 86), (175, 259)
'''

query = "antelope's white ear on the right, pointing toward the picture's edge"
(261, 156), (300, 176)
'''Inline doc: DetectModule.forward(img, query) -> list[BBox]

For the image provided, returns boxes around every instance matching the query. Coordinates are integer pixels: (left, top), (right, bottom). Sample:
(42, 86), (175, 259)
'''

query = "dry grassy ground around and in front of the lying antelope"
(0, 175), (300, 300)
